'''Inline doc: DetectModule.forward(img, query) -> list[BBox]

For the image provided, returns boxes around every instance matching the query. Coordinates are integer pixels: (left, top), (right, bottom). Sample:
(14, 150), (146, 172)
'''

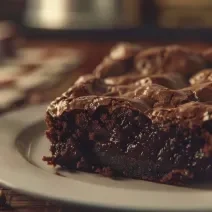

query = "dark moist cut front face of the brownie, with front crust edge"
(44, 96), (212, 184)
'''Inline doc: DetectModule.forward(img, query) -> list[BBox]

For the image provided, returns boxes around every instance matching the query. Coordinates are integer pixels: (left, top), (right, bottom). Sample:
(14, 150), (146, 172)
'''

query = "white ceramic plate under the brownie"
(0, 105), (212, 211)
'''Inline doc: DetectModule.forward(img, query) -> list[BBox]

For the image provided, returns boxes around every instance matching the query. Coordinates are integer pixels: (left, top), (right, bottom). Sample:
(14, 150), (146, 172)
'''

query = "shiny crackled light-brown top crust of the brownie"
(47, 43), (212, 128)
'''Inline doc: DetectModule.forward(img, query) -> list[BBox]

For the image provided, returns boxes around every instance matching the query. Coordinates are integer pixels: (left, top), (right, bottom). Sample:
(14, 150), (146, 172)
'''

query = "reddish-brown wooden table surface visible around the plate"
(0, 40), (212, 212)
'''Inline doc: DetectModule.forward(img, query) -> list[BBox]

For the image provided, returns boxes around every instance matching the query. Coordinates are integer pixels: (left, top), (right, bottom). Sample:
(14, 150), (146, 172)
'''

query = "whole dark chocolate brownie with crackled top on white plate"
(43, 43), (212, 185)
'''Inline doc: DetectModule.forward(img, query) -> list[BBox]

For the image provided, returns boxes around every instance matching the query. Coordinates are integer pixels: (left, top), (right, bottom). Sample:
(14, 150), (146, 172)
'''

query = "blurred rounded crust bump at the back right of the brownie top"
(135, 45), (207, 77)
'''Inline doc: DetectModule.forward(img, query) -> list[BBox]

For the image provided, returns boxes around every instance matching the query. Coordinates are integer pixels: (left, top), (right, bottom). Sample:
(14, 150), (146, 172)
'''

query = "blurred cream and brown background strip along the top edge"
(0, 0), (212, 35)
